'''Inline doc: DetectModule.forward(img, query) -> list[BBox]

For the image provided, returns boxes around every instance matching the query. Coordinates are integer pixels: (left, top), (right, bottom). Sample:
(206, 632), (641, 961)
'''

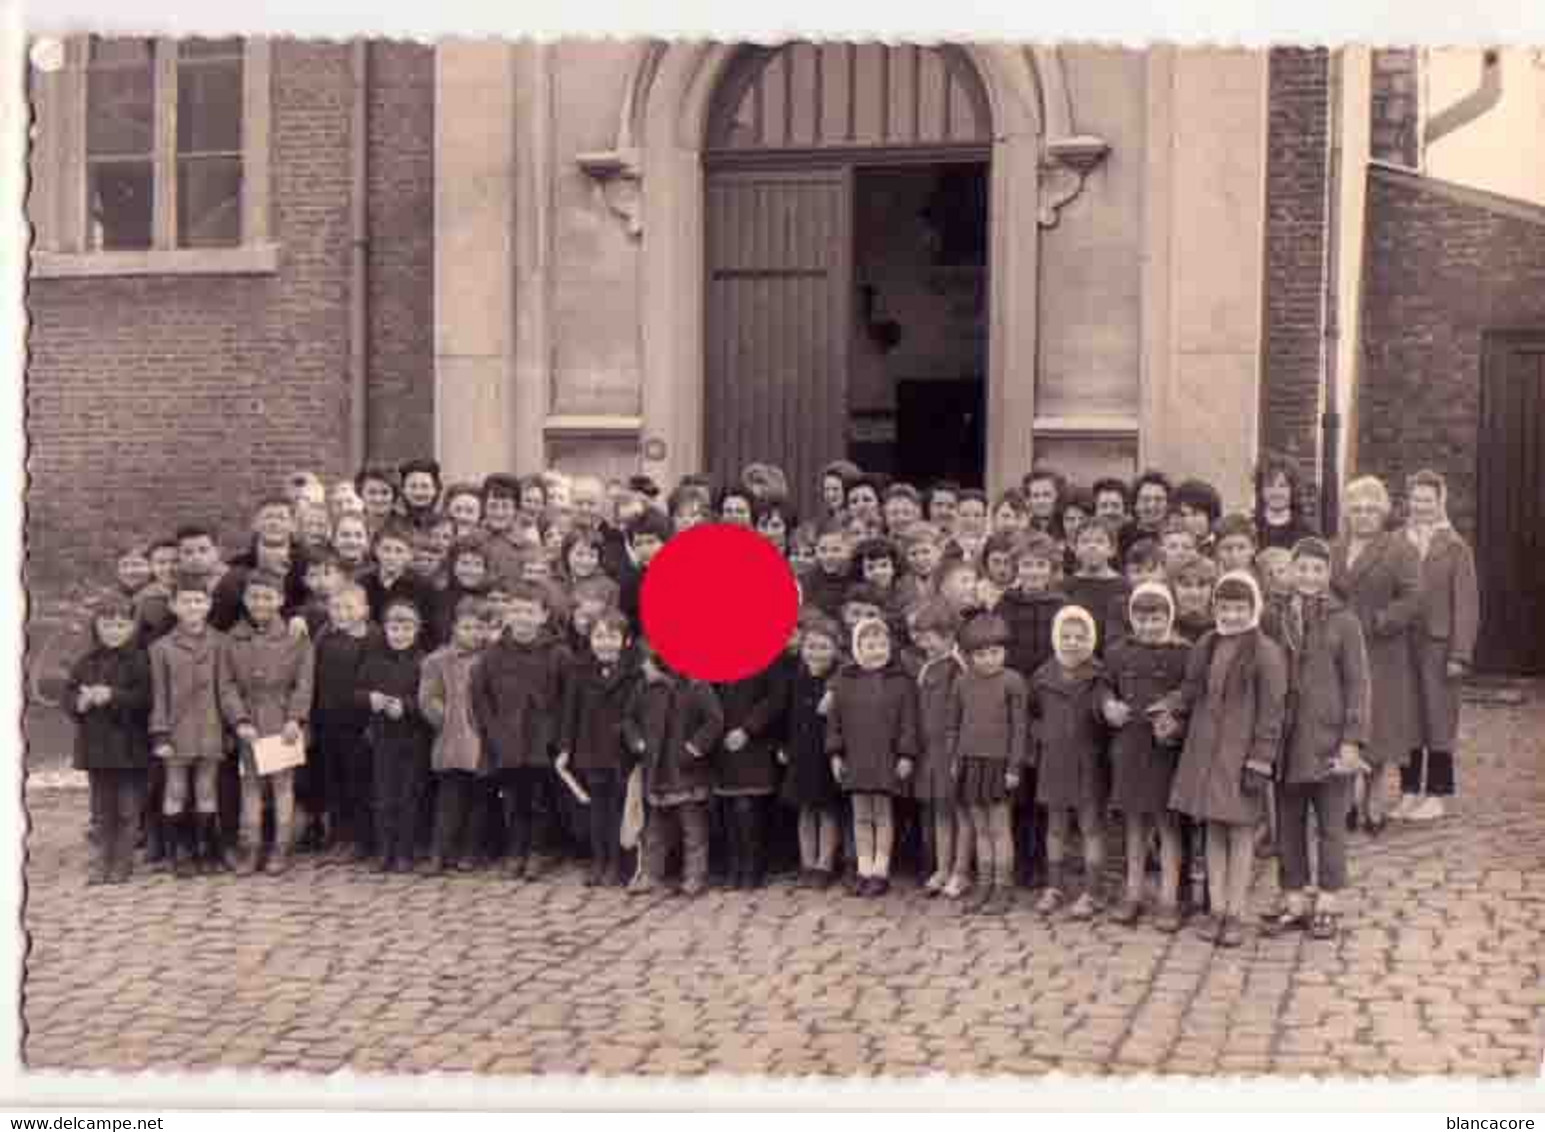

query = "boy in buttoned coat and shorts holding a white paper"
(219, 570), (315, 876)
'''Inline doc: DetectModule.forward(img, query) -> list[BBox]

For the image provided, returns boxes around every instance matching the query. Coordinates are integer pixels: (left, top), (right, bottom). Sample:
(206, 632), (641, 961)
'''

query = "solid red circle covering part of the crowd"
(638, 524), (799, 683)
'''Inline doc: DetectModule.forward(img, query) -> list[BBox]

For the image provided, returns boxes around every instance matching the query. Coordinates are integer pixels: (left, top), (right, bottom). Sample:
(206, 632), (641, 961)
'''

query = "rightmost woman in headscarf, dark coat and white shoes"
(1395, 471), (1480, 822)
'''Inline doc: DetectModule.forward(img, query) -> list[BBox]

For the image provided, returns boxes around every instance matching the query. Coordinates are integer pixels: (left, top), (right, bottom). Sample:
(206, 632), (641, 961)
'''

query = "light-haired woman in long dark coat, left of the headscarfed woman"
(1330, 476), (1421, 834)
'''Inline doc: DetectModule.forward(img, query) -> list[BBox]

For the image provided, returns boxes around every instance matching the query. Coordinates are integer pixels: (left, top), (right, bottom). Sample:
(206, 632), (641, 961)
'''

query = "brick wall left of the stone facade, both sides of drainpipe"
(26, 40), (433, 585)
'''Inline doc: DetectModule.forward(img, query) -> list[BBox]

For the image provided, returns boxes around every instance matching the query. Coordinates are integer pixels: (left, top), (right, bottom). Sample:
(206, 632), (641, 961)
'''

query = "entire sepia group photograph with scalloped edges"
(22, 34), (1545, 1083)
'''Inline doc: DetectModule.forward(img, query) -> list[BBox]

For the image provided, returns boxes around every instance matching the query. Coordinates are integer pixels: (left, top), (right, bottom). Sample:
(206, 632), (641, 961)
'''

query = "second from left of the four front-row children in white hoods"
(1031, 599), (1125, 919)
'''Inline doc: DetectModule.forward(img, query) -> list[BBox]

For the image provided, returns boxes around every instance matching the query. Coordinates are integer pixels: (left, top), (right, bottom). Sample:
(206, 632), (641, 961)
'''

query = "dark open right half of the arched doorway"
(848, 162), (987, 486)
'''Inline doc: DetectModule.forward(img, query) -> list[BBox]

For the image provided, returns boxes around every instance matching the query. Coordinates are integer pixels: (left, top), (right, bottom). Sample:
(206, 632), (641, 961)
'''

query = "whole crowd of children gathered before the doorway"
(66, 460), (1369, 947)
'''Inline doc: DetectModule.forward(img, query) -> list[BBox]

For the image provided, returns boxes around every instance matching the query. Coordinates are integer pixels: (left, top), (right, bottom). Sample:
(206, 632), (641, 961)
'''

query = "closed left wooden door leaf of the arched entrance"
(703, 168), (851, 516)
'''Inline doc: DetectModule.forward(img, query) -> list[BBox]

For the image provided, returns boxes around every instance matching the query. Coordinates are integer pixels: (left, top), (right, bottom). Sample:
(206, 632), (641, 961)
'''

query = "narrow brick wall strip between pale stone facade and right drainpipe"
(1261, 48), (1329, 506)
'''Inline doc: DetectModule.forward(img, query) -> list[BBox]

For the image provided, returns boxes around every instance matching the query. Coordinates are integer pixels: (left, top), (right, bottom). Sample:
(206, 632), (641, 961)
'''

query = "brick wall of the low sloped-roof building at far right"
(1349, 168), (1545, 539)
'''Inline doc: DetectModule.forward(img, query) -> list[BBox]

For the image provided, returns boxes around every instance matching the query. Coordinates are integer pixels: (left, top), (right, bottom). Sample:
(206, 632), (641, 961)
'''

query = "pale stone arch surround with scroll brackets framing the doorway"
(581, 42), (1105, 491)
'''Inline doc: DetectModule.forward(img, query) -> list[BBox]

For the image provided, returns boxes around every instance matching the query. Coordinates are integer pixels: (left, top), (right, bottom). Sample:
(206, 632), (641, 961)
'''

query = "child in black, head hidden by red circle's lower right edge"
(714, 639), (789, 888)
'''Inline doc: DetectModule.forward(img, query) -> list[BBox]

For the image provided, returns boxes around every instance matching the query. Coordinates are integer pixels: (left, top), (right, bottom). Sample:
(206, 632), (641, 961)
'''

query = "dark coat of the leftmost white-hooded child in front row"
(827, 664), (922, 794)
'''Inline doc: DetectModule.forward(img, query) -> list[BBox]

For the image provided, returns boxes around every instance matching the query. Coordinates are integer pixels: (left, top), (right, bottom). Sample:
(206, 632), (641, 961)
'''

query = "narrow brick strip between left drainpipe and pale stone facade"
(366, 43), (434, 462)
